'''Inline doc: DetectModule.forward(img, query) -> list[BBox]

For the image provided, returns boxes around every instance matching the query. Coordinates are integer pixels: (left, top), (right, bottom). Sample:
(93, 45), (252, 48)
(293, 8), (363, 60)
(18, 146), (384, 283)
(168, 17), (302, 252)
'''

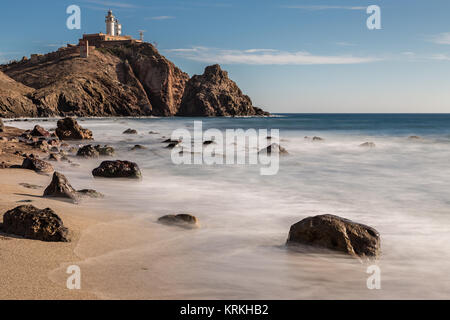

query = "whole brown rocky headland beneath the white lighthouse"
(0, 43), (264, 117)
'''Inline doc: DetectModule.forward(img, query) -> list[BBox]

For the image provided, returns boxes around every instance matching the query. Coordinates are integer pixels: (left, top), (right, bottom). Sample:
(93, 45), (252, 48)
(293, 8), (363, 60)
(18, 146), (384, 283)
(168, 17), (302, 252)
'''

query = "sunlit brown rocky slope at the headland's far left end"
(0, 71), (37, 118)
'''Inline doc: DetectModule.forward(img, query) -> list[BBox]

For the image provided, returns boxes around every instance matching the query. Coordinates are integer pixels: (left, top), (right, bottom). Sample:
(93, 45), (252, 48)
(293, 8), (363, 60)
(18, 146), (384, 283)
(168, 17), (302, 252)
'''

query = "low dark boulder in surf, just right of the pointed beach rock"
(92, 160), (142, 179)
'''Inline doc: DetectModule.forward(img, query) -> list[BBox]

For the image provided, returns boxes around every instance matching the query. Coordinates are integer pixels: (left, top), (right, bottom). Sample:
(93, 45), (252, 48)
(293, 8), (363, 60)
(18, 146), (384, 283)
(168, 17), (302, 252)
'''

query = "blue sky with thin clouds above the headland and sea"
(0, 0), (450, 112)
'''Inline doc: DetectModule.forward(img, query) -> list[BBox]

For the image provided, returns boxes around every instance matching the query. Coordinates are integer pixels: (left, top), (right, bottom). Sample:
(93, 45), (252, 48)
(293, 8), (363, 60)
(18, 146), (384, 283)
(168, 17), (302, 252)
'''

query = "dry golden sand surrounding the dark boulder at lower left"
(0, 169), (100, 299)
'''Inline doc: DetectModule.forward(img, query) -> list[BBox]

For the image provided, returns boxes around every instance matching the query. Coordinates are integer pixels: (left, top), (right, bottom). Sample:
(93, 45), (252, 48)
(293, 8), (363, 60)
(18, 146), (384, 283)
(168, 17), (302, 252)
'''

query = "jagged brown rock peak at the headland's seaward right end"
(178, 64), (267, 117)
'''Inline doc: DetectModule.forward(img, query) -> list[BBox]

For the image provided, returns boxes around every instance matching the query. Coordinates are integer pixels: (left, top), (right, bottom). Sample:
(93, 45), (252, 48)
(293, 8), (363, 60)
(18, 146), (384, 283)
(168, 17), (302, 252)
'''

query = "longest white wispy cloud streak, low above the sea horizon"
(166, 47), (382, 65)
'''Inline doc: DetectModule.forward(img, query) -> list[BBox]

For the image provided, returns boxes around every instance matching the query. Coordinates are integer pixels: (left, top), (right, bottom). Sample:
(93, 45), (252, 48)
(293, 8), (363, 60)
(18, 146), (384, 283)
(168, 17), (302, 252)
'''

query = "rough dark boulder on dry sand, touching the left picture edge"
(2, 205), (69, 242)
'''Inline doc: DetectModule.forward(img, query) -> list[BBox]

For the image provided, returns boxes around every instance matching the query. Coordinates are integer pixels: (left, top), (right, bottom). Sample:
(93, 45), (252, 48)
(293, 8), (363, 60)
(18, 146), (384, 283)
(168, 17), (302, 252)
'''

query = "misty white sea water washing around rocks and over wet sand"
(9, 114), (450, 299)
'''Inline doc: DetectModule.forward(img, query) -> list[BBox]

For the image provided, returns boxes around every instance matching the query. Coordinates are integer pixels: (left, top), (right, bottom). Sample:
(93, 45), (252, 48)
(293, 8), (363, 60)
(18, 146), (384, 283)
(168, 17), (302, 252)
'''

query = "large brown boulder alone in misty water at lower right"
(287, 214), (380, 257)
